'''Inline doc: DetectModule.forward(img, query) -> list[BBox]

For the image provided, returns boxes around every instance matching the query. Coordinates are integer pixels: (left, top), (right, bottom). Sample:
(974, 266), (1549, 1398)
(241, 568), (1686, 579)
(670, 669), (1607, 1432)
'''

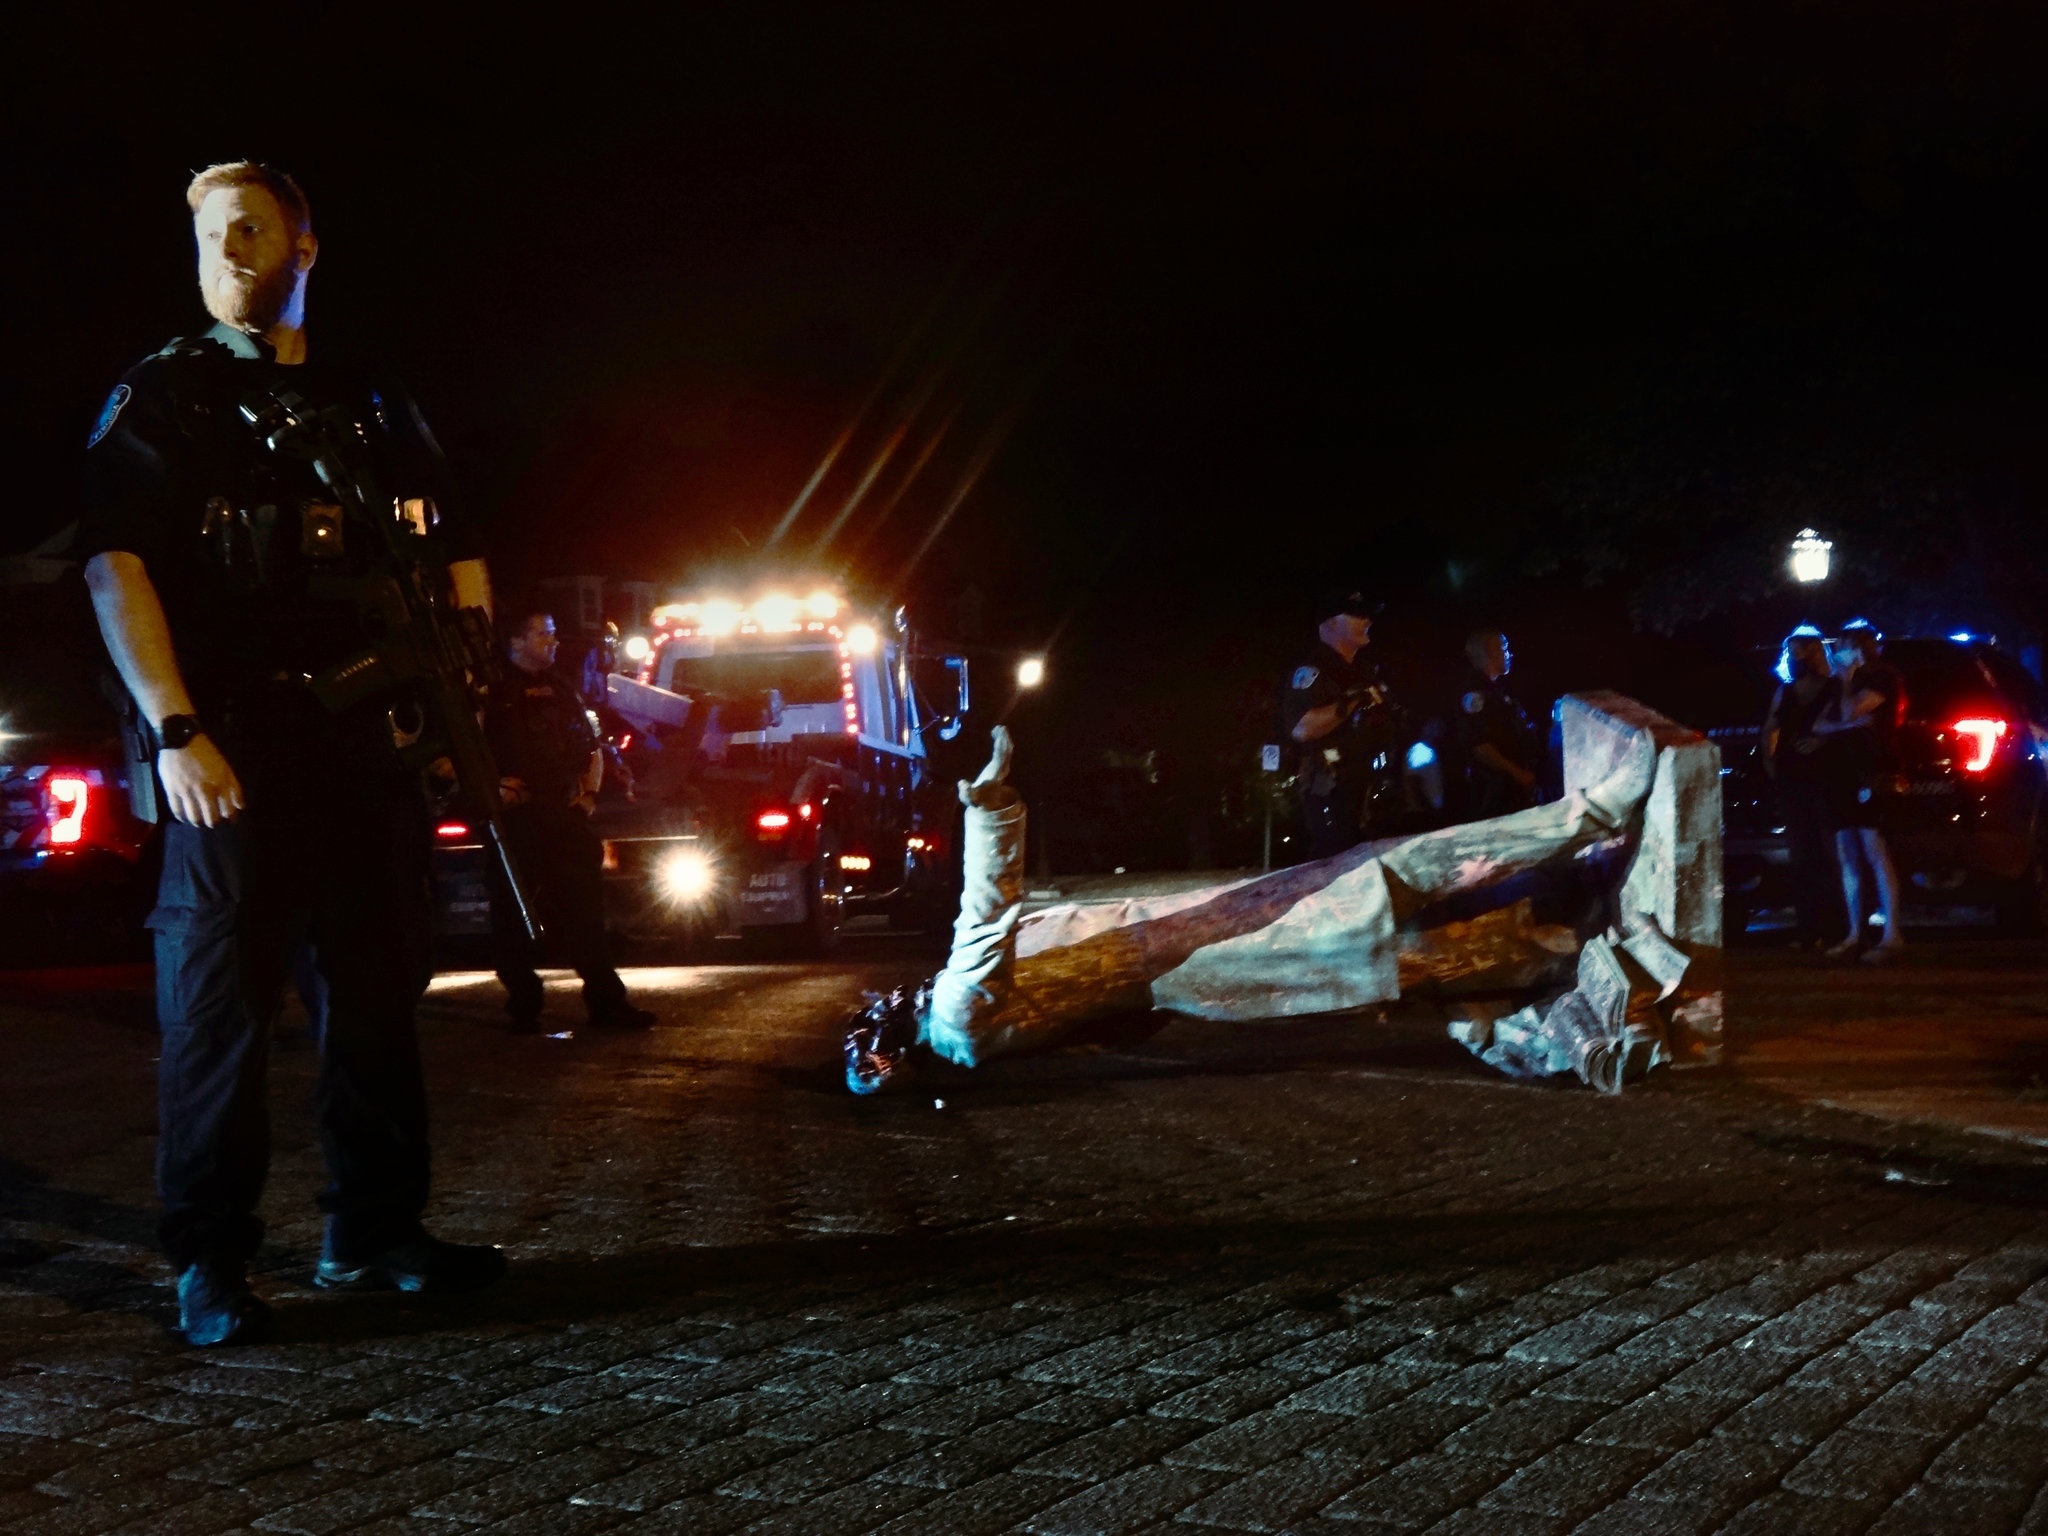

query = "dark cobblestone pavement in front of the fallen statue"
(0, 944), (2048, 1536)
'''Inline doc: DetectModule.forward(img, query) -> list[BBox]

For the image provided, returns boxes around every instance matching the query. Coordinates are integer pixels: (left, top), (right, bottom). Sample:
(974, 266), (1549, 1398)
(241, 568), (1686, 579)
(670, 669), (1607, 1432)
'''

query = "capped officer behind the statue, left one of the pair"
(1286, 590), (1391, 858)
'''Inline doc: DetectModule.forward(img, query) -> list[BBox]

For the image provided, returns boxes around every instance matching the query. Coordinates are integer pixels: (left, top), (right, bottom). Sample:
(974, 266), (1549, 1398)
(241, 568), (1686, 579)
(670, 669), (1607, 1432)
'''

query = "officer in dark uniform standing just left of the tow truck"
(483, 608), (653, 1034)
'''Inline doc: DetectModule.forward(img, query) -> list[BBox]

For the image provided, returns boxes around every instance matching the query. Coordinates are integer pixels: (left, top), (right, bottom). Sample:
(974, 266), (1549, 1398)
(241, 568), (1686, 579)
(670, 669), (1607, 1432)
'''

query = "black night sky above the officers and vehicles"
(0, 2), (2048, 843)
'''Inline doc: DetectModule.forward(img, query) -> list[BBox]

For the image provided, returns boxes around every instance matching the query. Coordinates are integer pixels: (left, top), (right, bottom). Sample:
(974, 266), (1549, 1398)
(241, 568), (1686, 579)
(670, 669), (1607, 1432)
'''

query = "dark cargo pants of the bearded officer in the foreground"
(150, 766), (430, 1268)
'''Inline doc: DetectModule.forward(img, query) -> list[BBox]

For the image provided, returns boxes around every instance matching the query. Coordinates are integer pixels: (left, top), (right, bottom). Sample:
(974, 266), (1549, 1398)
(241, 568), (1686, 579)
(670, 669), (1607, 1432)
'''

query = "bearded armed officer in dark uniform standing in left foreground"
(78, 162), (504, 1346)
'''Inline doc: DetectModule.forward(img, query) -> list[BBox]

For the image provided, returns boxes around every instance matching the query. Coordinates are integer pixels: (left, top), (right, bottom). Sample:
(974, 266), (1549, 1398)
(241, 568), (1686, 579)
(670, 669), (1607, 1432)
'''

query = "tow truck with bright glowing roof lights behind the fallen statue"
(438, 590), (969, 954)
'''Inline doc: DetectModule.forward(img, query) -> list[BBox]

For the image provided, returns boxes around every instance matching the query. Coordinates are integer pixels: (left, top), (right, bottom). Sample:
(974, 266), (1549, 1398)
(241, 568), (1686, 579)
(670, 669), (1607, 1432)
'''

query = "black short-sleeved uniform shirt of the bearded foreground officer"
(74, 326), (477, 715)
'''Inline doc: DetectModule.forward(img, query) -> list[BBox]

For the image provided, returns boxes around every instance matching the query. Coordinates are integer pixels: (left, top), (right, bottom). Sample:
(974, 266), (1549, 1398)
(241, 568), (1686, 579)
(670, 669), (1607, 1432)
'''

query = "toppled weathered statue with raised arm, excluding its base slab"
(846, 727), (1686, 1094)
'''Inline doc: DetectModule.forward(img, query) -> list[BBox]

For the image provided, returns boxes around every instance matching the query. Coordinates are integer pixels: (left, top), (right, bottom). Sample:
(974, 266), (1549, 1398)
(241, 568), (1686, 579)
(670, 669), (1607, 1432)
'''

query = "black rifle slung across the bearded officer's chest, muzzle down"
(242, 385), (541, 940)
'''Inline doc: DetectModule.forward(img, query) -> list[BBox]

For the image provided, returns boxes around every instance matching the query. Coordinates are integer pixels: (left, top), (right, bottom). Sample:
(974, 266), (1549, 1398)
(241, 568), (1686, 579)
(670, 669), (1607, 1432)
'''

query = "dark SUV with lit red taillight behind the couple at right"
(1710, 635), (2048, 934)
